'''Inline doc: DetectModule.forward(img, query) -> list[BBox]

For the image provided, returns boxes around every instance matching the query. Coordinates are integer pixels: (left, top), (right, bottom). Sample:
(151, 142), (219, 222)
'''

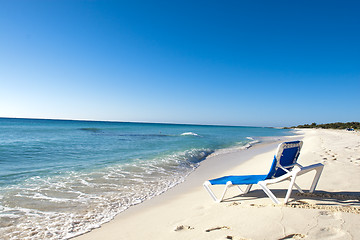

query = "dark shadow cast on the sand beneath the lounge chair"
(223, 189), (360, 206)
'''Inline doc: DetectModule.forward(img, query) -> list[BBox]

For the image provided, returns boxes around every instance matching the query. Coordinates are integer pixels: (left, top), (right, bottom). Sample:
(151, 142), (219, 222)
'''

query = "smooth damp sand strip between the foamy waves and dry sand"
(74, 134), (302, 240)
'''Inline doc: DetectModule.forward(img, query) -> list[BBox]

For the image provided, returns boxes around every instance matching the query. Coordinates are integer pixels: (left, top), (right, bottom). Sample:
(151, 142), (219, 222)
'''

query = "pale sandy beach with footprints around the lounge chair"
(75, 129), (360, 240)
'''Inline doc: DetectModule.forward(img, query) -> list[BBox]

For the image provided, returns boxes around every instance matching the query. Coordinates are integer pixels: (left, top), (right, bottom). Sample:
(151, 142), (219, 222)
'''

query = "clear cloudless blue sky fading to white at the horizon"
(0, 0), (360, 126)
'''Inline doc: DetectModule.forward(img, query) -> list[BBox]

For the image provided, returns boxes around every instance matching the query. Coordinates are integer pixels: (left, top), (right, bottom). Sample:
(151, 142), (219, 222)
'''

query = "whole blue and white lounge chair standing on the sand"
(204, 141), (324, 204)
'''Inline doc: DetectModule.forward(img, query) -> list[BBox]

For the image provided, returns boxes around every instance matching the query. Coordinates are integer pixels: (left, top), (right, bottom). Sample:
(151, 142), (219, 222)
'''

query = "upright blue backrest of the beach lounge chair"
(266, 141), (303, 179)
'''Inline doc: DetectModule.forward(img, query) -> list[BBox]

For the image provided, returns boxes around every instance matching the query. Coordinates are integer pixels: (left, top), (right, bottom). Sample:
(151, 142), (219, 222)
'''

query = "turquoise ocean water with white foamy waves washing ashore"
(0, 118), (290, 239)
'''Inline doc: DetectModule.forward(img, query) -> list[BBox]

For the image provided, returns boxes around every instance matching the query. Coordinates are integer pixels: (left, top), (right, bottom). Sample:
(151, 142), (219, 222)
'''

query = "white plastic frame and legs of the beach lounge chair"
(203, 141), (324, 204)
